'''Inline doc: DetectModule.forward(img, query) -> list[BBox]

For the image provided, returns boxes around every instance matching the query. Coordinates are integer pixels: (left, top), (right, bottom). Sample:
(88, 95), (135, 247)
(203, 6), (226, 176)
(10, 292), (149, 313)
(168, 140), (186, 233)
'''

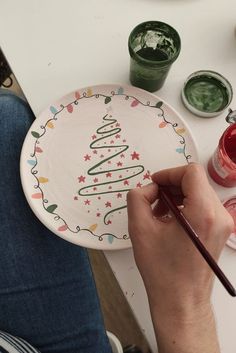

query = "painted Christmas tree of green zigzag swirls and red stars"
(75, 109), (150, 225)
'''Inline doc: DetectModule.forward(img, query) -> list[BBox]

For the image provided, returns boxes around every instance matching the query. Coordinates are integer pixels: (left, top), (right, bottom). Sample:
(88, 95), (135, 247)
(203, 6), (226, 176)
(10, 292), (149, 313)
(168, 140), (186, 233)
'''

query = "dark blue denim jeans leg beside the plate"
(0, 91), (111, 353)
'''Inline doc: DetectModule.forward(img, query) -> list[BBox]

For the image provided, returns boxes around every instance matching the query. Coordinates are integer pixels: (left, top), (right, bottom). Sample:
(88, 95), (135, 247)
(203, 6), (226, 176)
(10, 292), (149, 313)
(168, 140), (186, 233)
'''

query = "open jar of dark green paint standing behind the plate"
(128, 21), (181, 92)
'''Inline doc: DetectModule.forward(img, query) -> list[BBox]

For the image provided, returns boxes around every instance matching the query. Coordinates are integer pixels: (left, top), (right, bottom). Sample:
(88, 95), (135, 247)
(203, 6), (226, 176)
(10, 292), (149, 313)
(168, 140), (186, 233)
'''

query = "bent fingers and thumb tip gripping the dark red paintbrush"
(127, 163), (210, 220)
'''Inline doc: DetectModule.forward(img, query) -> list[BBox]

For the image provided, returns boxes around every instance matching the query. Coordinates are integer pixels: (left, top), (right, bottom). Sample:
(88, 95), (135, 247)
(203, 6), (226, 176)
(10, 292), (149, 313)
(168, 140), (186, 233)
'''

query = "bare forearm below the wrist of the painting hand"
(152, 300), (220, 353)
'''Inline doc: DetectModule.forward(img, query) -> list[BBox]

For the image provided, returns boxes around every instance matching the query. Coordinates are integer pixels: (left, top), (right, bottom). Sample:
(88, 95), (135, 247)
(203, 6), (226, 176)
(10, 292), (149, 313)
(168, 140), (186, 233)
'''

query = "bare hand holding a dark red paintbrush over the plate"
(127, 163), (233, 320)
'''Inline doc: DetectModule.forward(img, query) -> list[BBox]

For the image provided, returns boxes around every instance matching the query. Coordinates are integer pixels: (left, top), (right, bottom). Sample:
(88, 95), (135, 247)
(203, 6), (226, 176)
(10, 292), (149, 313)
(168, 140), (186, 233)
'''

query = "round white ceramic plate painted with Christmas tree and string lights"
(21, 85), (197, 250)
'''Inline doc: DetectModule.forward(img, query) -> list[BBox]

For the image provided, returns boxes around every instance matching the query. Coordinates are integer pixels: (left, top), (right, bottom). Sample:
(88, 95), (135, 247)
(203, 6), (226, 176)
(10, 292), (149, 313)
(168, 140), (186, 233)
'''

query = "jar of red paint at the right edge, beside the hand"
(208, 123), (236, 187)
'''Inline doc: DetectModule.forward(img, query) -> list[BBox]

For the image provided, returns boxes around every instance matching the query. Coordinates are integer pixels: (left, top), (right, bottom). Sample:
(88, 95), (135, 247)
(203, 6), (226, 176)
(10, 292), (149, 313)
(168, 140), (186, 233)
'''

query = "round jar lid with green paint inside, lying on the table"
(182, 70), (233, 118)
